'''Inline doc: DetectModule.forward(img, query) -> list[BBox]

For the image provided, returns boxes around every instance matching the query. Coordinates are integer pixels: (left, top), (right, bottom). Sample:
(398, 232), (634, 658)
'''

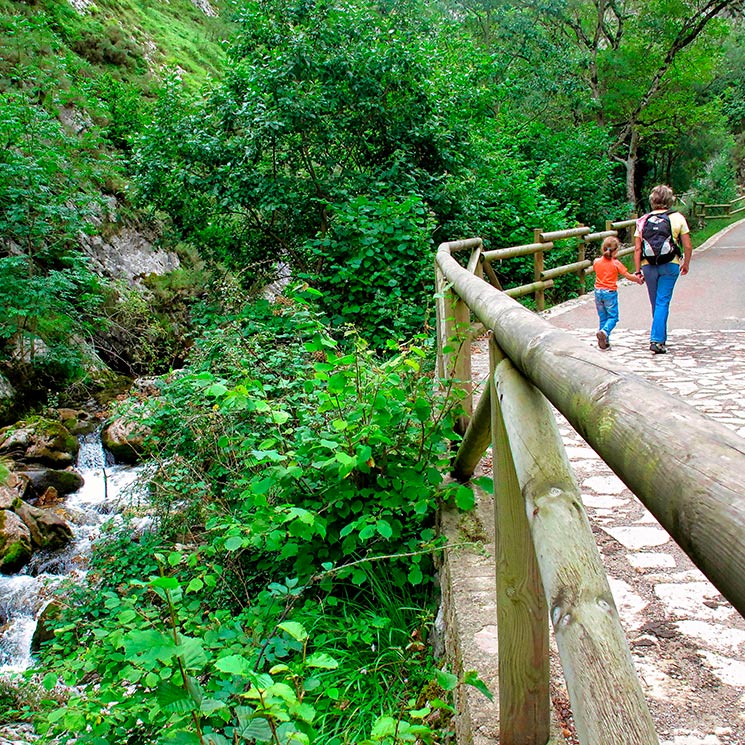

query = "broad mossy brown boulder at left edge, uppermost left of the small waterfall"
(0, 417), (80, 468)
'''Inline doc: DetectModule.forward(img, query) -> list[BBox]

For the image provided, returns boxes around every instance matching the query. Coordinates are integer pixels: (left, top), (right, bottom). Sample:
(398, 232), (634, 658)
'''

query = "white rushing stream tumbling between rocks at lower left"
(0, 432), (143, 676)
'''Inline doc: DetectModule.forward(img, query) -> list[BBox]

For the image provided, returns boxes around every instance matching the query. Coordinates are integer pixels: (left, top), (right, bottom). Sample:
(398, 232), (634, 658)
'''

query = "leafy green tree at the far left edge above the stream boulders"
(0, 87), (109, 398)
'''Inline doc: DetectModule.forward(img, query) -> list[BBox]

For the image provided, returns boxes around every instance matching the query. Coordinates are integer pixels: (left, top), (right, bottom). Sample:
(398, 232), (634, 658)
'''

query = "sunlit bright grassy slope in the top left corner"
(0, 0), (230, 88)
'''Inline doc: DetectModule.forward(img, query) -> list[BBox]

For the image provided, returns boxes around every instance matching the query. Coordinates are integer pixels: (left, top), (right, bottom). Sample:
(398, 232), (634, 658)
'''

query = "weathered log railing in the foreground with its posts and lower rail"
(436, 234), (745, 745)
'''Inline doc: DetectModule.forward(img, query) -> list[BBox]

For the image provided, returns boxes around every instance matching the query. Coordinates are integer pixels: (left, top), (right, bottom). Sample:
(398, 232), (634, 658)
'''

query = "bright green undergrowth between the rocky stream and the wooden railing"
(24, 294), (482, 745)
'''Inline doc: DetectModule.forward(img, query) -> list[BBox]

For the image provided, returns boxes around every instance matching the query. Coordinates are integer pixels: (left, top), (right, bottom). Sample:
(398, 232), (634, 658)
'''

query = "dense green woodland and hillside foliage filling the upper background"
(0, 0), (743, 396)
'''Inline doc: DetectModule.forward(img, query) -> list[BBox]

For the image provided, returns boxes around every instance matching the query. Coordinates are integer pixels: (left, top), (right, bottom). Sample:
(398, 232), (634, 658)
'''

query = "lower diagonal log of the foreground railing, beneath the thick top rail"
(494, 352), (659, 745)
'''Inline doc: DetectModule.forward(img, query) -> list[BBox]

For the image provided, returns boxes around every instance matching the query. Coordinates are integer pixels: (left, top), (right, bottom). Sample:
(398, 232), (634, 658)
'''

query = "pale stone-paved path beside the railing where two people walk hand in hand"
(462, 223), (745, 745)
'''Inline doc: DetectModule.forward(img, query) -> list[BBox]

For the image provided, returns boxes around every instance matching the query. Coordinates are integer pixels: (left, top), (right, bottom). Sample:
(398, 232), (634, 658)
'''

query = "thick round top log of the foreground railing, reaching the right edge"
(436, 244), (745, 616)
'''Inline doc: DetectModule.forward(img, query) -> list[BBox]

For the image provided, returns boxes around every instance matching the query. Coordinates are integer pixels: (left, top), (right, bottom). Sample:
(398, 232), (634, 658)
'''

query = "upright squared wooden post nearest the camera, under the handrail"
(489, 338), (551, 745)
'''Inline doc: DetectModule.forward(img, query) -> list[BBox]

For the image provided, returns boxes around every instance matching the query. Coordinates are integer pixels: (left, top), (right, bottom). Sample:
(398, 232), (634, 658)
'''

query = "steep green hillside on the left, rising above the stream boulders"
(0, 0), (231, 421)
